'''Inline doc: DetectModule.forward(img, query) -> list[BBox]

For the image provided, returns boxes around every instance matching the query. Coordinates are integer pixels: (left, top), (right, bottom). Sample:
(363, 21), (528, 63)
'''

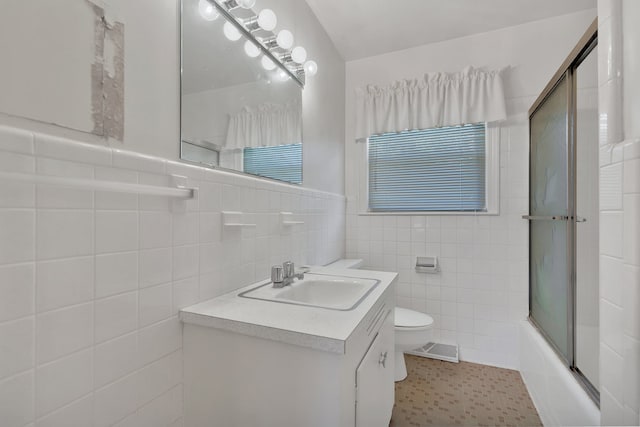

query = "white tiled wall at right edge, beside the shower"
(600, 139), (640, 425)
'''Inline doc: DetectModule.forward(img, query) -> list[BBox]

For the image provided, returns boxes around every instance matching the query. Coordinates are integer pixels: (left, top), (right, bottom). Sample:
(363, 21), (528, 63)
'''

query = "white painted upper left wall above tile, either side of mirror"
(0, 0), (344, 193)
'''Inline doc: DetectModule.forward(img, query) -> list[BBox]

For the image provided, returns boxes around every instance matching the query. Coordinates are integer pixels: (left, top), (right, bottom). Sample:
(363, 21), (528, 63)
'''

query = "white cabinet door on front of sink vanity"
(356, 311), (395, 427)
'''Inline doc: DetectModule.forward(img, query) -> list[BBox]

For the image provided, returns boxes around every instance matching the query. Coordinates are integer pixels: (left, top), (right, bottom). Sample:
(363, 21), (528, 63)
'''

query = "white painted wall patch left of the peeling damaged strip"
(0, 1), (95, 132)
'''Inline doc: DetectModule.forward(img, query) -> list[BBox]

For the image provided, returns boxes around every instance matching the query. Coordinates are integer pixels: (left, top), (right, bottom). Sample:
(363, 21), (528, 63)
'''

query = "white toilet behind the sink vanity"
(326, 259), (433, 381)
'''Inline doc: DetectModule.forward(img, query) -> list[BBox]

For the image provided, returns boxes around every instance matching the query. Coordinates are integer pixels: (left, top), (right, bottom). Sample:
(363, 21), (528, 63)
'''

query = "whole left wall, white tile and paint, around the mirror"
(0, 0), (346, 427)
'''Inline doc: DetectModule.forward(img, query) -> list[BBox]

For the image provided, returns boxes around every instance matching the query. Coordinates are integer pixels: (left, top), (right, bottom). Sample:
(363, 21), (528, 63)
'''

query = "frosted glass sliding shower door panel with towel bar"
(526, 72), (574, 365)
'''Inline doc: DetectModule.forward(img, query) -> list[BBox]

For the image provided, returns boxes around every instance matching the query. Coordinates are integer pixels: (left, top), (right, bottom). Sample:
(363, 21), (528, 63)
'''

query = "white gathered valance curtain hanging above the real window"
(356, 67), (507, 139)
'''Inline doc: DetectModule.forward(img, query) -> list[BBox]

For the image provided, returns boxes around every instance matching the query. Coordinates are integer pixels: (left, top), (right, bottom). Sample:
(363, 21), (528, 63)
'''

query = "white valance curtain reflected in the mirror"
(224, 101), (302, 150)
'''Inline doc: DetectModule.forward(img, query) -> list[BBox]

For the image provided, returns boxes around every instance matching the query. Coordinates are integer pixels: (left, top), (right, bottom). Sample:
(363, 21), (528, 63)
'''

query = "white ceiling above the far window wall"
(306, 0), (596, 61)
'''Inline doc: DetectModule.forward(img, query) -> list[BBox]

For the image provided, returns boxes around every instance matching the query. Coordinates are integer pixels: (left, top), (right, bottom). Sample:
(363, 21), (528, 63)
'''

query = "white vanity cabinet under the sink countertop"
(182, 273), (395, 427)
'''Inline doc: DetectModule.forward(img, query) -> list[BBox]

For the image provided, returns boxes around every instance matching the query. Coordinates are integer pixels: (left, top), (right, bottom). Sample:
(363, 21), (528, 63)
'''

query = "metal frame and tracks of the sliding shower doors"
(523, 18), (600, 407)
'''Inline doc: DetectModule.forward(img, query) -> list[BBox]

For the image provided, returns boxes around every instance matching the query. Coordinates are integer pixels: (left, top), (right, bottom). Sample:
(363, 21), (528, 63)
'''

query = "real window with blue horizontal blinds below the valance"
(367, 123), (499, 213)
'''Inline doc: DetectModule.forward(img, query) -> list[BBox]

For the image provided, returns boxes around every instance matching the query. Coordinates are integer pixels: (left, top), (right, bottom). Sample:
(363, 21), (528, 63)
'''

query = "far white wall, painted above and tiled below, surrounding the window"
(345, 10), (595, 368)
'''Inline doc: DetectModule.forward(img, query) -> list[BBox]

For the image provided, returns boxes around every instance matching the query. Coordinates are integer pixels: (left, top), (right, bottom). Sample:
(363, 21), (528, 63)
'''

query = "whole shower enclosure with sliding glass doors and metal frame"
(524, 19), (599, 403)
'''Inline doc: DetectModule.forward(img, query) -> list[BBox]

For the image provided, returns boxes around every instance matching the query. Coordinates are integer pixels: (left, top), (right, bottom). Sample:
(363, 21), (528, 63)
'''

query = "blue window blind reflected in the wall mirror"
(243, 143), (302, 184)
